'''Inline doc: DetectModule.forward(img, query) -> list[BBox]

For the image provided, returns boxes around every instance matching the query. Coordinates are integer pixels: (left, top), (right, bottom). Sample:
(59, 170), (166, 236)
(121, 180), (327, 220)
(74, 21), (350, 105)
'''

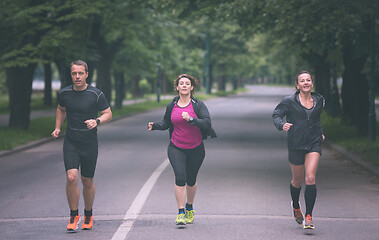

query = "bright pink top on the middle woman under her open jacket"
(171, 102), (203, 149)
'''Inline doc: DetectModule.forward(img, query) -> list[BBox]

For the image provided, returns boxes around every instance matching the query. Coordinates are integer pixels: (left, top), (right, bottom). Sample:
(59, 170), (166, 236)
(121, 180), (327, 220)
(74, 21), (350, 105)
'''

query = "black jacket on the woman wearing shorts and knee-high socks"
(272, 91), (325, 150)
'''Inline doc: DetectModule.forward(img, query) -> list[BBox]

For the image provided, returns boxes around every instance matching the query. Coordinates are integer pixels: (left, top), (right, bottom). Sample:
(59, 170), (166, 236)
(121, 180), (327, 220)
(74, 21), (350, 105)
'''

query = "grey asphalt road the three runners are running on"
(0, 86), (379, 240)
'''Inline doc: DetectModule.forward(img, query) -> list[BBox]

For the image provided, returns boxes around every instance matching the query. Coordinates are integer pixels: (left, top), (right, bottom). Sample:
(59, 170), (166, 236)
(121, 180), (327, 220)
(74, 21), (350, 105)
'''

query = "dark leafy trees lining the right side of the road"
(220, 0), (379, 134)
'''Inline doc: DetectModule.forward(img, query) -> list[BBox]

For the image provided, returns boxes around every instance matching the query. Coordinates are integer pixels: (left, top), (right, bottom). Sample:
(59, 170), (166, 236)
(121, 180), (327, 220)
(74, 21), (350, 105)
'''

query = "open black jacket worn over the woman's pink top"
(152, 96), (217, 139)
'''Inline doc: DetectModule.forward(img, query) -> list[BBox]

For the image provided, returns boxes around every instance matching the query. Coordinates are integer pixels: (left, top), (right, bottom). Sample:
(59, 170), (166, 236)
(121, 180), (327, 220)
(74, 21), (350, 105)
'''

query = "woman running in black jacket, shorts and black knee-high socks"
(272, 71), (325, 229)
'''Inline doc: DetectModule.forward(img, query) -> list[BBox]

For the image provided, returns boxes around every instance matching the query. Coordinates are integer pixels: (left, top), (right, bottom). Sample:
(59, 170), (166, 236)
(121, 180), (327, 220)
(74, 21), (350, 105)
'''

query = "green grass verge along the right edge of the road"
(321, 112), (379, 167)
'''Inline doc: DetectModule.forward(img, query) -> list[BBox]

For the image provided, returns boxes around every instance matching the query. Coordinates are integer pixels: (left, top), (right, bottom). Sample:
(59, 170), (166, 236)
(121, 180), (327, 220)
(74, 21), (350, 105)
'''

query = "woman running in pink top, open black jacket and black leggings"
(148, 74), (216, 225)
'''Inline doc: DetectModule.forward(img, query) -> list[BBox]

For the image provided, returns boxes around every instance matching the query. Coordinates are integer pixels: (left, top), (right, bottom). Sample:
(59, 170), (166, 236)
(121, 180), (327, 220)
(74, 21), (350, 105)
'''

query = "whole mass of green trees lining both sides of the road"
(0, 0), (379, 139)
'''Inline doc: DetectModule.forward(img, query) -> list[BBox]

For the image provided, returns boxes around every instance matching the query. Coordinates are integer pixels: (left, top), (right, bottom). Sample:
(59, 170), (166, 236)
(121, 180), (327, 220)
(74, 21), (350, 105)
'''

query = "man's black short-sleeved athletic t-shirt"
(58, 85), (109, 141)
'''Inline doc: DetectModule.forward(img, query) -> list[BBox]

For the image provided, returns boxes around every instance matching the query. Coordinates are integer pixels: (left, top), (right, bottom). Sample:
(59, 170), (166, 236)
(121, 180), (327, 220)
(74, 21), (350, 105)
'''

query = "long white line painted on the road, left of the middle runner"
(112, 159), (169, 240)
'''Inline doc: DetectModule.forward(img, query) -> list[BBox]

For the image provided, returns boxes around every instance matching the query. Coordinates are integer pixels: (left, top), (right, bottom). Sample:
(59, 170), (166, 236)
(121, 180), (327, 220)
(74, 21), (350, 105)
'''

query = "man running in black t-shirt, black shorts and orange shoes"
(51, 60), (112, 231)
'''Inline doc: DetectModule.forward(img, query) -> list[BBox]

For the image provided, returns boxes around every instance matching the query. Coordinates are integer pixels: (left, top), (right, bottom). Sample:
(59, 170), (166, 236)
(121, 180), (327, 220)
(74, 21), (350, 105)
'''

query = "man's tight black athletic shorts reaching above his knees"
(63, 137), (98, 178)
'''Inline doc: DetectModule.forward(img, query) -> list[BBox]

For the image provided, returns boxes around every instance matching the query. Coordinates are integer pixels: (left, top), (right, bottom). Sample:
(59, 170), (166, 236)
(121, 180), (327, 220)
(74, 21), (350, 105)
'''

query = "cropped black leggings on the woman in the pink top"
(167, 141), (205, 187)
